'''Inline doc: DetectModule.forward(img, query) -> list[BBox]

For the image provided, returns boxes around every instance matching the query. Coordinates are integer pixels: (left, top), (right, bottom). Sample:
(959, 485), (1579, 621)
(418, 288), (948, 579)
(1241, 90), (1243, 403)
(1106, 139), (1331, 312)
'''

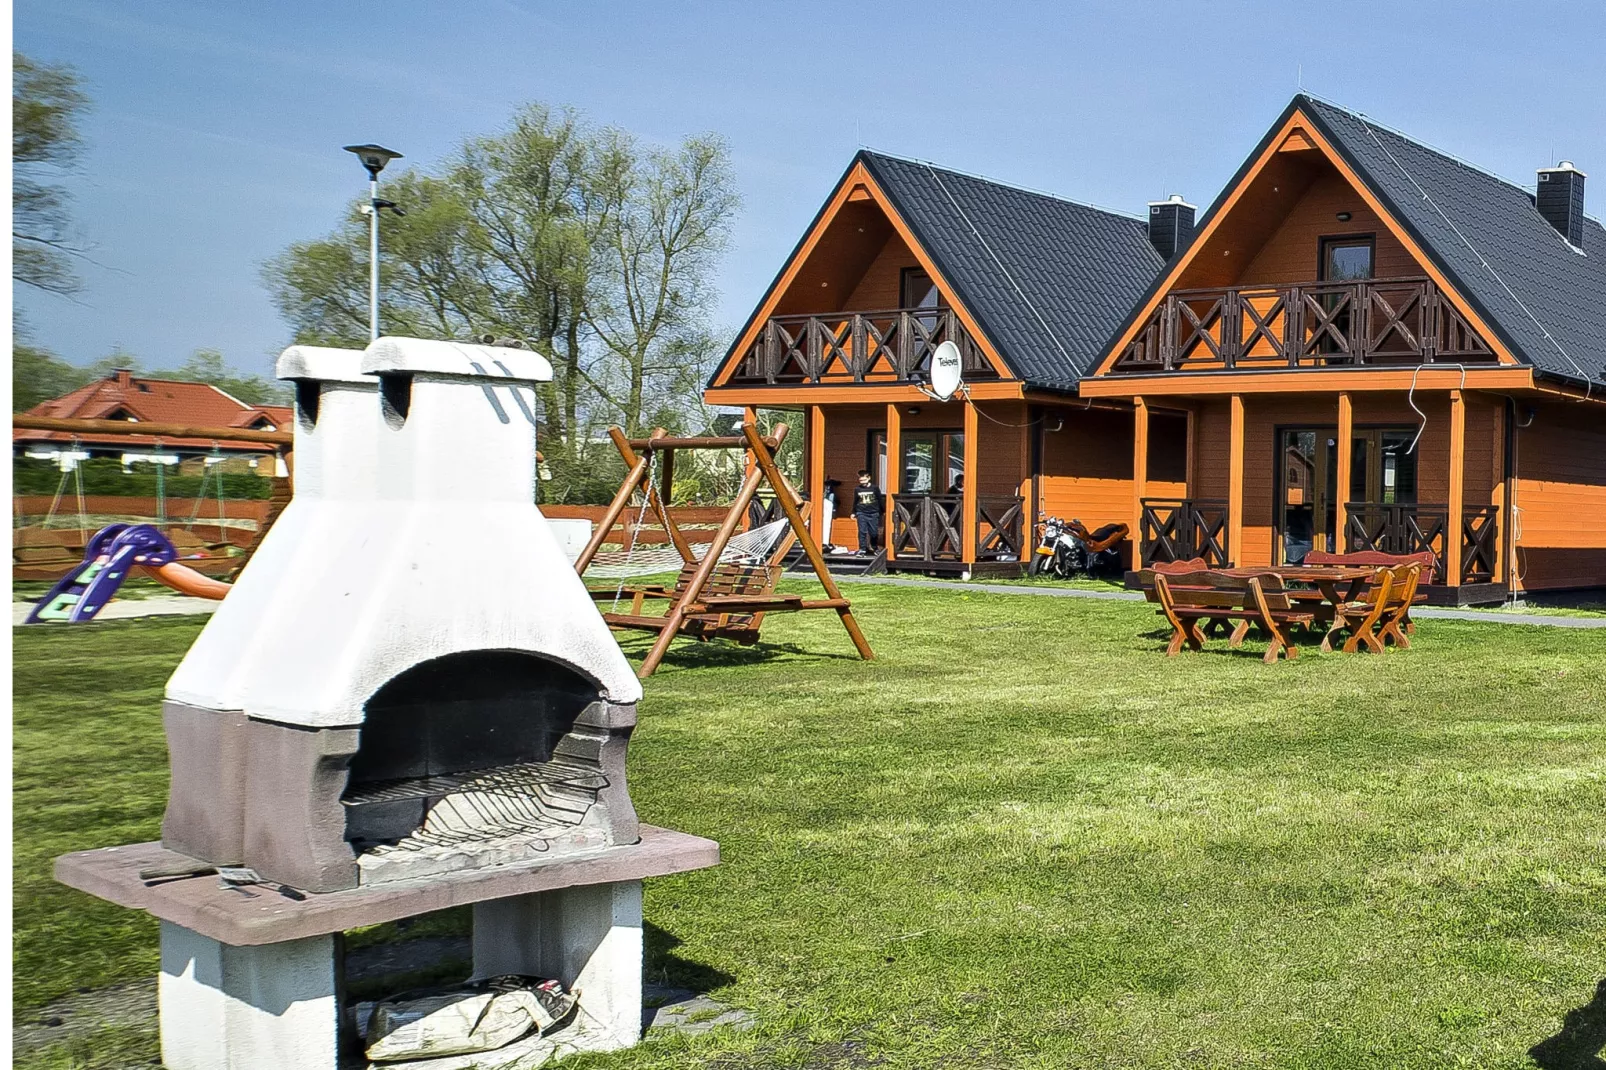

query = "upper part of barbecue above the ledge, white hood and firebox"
(162, 337), (641, 892)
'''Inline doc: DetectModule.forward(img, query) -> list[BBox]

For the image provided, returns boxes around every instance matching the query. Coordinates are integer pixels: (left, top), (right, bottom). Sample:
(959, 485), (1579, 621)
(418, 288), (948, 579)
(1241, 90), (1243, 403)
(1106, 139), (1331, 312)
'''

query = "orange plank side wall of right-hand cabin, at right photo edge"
(1509, 402), (1606, 591)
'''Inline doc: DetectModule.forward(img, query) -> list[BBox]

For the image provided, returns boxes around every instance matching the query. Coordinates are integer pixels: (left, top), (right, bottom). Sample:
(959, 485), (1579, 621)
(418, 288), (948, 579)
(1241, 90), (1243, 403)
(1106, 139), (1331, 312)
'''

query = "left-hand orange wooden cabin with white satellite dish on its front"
(705, 151), (1187, 574)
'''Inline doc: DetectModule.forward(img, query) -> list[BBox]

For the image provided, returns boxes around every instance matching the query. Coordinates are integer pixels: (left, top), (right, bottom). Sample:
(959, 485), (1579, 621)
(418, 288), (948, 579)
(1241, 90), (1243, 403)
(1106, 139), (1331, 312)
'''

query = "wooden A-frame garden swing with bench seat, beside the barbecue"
(575, 424), (875, 680)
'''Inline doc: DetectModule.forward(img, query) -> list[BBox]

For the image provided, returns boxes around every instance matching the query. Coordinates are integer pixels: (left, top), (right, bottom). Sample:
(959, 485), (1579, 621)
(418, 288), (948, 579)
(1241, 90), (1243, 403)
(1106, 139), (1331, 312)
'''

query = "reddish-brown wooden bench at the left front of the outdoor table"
(1153, 572), (1315, 665)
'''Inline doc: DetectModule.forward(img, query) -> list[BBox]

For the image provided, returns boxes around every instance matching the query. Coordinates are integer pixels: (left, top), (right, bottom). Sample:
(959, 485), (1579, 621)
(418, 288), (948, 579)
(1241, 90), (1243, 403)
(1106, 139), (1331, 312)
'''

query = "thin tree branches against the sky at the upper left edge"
(11, 51), (90, 294)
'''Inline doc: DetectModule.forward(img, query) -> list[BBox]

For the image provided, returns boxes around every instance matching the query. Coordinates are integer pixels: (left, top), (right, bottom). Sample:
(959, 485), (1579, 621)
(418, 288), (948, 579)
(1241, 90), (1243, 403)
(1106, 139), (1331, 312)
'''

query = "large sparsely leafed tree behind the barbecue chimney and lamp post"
(263, 104), (737, 501)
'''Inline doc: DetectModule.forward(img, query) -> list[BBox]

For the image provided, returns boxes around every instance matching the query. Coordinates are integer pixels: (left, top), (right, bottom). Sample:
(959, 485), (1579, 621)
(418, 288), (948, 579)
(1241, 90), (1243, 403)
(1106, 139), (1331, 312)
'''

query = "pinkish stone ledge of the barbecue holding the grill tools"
(55, 824), (719, 946)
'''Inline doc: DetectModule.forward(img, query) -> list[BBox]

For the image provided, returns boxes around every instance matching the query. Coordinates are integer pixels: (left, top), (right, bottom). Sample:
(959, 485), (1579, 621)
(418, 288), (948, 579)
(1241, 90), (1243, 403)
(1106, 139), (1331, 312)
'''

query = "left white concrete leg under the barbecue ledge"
(156, 922), (340, 1070)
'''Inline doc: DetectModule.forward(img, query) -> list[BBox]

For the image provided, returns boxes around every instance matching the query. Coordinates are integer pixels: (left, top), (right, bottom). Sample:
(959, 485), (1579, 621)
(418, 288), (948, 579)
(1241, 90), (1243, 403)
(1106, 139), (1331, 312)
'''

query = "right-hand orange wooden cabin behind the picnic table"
(1079, 96), (1606, 602)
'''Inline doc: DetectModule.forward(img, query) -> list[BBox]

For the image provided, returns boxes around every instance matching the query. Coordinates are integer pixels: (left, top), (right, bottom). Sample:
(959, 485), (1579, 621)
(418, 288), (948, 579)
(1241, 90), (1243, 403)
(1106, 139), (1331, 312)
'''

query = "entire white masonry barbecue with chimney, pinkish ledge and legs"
(56, 337), (718, 1070)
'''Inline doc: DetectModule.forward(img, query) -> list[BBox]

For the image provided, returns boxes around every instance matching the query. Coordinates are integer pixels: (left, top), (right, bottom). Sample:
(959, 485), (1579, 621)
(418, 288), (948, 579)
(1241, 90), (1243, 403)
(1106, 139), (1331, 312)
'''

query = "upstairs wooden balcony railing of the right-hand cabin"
(1111, 278), (1495, 374)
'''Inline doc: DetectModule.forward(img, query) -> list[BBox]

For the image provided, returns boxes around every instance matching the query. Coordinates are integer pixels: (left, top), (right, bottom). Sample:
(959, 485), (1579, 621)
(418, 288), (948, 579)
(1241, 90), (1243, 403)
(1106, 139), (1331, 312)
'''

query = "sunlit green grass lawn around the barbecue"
(14, 585), (1606, 1070)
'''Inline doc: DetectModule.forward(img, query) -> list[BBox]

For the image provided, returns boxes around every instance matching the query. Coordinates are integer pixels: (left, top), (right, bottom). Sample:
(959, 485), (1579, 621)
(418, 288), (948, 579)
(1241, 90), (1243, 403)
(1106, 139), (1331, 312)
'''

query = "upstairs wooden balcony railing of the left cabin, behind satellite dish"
(731, 308), (997, 384)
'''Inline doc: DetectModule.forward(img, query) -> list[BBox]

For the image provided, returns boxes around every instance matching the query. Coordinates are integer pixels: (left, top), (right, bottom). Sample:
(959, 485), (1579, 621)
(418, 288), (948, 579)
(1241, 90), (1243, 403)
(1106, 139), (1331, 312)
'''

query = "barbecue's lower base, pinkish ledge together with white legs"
(56, 826), (719, 1070)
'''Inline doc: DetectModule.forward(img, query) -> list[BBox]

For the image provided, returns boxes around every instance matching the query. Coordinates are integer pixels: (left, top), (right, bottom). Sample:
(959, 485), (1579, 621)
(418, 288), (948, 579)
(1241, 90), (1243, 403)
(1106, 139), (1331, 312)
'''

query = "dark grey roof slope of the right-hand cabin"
(1297, 95), (1606, 382)
